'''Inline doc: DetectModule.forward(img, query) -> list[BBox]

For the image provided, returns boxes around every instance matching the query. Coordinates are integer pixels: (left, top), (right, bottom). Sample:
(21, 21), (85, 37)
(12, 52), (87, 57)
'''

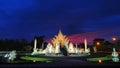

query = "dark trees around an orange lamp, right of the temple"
(93, 38), (120, 51)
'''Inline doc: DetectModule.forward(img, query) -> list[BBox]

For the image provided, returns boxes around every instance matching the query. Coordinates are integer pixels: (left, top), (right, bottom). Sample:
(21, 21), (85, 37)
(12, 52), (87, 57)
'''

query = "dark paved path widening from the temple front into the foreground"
(0, 57), (120, 68)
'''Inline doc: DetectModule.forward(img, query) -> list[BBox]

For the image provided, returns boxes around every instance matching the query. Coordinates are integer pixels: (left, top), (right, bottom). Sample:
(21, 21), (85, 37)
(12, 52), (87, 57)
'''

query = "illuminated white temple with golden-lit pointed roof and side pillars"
(32, 31), (90, 56)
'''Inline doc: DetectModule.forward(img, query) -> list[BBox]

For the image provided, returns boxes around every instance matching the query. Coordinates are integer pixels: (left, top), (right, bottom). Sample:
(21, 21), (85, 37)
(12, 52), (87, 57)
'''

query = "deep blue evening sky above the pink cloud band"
(0, 0), (120, 40)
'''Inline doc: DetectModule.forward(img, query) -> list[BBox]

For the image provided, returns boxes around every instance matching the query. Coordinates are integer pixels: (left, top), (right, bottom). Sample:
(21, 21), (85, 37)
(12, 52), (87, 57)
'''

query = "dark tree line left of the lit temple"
(0, 36), (44, 51)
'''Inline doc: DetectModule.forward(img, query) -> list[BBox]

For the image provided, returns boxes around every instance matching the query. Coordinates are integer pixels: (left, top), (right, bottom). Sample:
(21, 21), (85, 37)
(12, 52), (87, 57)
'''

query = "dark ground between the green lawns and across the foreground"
(0, 54), (120, 68)
